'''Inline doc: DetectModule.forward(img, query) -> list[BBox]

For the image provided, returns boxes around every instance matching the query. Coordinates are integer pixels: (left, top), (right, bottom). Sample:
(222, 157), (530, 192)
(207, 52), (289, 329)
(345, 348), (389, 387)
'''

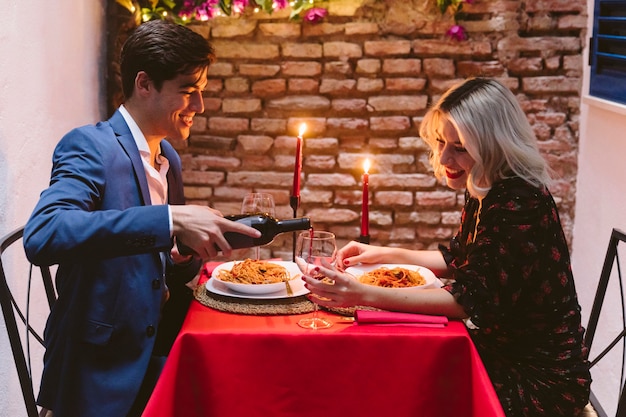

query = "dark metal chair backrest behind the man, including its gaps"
(0, 227), (56, 417)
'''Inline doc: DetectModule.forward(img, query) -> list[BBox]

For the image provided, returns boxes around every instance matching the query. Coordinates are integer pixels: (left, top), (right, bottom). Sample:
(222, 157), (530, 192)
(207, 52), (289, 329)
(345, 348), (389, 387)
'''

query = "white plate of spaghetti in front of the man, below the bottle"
(206, 259), (309, 298)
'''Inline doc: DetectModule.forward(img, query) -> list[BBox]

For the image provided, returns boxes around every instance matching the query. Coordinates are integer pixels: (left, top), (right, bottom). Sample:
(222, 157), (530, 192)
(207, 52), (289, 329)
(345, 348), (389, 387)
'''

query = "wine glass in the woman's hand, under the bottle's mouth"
(296, 229), (337, 329)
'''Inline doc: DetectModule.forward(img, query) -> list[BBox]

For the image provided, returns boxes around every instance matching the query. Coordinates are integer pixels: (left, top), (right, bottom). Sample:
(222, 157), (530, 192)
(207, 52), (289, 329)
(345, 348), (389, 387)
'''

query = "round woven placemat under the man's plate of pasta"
(193, 285), (314, 316)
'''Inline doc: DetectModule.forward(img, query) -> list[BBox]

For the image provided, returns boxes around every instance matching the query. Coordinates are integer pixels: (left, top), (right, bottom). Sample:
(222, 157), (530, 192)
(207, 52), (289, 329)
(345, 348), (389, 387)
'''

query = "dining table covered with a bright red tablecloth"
(143, 263), (504, 417)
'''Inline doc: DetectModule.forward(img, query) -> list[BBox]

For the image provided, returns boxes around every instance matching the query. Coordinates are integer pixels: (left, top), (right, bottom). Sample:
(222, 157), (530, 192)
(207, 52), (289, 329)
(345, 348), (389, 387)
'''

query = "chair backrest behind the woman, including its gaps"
(585, 229), (626, 417)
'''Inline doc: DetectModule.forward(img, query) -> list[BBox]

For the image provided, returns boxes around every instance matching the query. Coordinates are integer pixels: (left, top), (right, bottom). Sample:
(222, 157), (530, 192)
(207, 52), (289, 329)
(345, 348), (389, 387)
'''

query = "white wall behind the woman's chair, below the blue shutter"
(572, 0), (626, 415)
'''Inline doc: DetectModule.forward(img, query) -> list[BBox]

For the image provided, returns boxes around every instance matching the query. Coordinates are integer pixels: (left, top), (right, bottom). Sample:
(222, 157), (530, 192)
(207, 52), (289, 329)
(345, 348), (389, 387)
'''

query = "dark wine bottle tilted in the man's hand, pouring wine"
(177, 213), (311, 255)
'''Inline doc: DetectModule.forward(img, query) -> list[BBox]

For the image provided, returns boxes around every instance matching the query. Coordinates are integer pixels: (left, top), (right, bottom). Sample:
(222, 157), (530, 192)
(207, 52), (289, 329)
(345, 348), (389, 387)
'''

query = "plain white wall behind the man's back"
(0, 0), (106, 416)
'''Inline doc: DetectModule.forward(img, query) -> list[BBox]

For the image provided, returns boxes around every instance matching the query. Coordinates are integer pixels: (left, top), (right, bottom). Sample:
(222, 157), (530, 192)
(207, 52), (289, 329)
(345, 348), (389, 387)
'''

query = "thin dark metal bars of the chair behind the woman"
(585, 229), (626, 417)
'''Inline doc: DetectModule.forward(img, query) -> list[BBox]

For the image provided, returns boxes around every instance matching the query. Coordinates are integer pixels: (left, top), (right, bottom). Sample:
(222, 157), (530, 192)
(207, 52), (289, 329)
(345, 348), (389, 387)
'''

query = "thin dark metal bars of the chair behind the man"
(0, 226), (56, 417)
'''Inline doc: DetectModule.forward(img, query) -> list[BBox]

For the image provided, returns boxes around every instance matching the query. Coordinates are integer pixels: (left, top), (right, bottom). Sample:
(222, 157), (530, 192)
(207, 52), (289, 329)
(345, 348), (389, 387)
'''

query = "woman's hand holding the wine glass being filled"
(296, 257), (367, 307)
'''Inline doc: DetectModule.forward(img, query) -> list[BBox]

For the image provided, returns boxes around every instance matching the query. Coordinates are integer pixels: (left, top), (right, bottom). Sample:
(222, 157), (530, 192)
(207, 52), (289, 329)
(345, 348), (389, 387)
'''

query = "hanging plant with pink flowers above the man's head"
(116, 0), (328, 25)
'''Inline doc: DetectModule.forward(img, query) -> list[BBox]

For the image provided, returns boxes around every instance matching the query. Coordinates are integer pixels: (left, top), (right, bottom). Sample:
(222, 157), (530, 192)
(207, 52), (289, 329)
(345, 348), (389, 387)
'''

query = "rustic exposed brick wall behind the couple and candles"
(106, 0), (587, 259)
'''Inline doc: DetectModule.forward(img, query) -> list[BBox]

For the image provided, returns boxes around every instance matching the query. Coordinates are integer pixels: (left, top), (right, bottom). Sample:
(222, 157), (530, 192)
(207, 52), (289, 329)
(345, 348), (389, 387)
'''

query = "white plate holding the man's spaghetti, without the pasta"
(205, 261), (309, 299)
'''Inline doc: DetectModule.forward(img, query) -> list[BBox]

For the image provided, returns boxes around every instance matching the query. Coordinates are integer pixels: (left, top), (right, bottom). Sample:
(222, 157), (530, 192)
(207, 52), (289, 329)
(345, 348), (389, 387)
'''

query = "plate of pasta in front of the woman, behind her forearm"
(346, 264), (443, 288)
